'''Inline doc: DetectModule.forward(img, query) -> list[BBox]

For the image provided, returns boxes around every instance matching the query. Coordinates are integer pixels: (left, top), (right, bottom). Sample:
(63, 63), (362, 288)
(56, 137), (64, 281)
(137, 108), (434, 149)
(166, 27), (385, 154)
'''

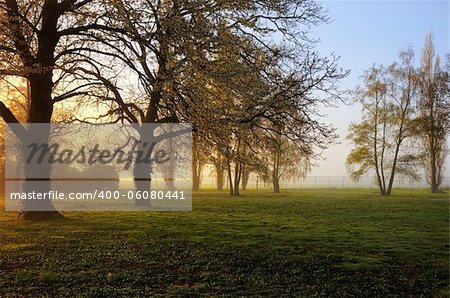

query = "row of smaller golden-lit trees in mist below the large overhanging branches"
(192, 126), (314, 196)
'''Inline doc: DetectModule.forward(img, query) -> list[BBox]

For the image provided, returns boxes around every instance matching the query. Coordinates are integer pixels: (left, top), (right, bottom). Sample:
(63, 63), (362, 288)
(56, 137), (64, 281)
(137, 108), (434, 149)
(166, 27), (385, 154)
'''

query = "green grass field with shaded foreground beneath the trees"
(0, 190), (449, 297)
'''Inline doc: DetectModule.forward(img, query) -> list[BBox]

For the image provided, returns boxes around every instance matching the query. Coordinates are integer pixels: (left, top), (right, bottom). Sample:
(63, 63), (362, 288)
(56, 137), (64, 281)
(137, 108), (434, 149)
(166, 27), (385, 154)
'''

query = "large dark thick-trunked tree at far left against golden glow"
(0, 0), (123, 219)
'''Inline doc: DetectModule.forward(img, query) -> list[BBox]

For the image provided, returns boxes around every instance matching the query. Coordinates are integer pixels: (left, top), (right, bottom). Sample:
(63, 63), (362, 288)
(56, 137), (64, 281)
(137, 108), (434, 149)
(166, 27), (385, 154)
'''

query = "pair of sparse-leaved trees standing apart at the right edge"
(347, 33), (450, 195)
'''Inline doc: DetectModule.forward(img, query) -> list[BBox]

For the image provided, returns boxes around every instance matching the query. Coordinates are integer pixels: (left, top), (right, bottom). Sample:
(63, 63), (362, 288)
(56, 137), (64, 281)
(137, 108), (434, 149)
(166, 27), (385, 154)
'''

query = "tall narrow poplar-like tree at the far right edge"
(418, 33), (450, 193)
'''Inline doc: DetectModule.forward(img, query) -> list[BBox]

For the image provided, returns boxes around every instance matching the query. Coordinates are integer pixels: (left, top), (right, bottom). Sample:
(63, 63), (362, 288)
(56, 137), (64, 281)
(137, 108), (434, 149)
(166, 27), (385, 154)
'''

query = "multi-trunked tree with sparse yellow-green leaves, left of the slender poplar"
(346, 50), (418, 195)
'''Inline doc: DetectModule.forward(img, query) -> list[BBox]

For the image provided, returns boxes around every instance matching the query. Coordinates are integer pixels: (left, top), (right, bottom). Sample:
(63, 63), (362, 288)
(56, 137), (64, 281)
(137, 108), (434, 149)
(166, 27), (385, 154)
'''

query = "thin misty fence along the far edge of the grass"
(200, 175), (450, 189)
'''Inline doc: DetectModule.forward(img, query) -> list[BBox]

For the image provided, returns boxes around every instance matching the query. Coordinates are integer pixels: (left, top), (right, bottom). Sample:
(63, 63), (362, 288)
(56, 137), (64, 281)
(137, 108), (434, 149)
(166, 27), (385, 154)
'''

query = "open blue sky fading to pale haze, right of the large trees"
(311, 0), (450, 177)
